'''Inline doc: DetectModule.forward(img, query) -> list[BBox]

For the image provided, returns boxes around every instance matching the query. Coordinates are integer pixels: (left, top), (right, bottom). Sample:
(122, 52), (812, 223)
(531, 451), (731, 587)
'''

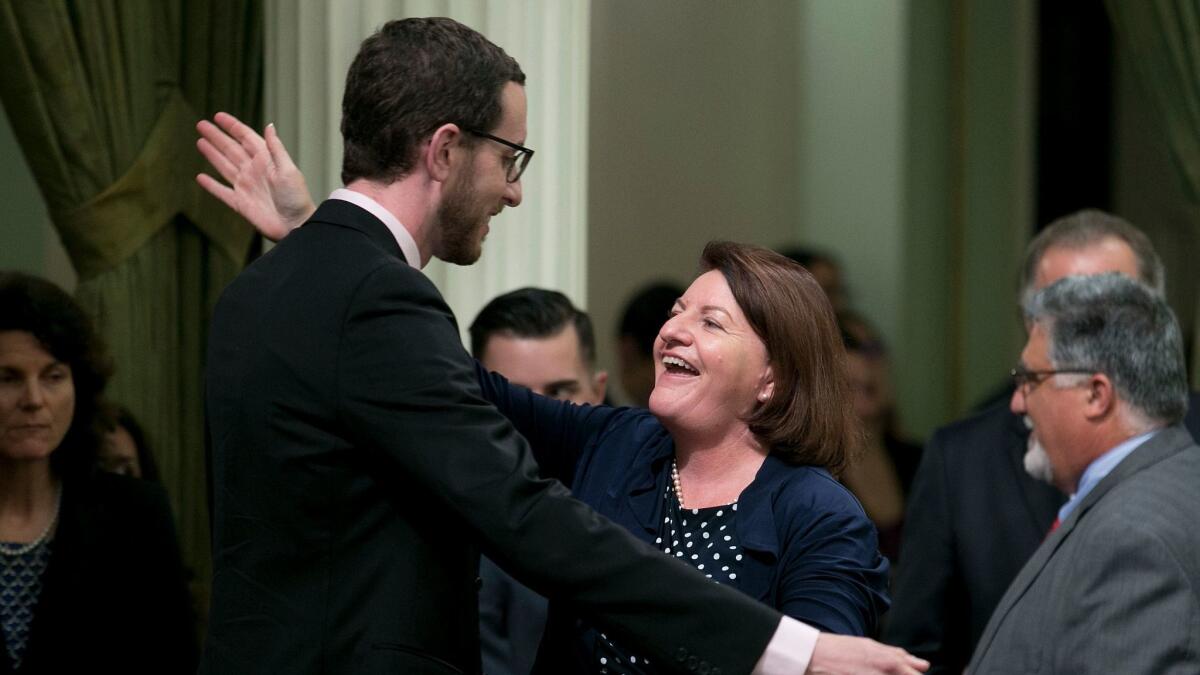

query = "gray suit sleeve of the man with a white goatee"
(1052, 516), (1200, 673)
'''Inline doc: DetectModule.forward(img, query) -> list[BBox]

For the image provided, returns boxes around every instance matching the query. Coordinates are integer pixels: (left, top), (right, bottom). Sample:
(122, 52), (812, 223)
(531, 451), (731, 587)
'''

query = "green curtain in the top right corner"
(1106, 0), (1200, 384)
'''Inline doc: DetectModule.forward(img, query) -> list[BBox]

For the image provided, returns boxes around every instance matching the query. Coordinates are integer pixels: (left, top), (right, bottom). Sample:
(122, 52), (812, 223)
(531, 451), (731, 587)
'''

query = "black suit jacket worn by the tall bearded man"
(202, 201), (779, 675)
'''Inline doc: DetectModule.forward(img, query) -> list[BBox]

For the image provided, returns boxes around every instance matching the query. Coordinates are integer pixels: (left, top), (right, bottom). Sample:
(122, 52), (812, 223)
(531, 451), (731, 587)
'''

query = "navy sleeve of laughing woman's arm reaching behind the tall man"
(475, 362), (613, 485)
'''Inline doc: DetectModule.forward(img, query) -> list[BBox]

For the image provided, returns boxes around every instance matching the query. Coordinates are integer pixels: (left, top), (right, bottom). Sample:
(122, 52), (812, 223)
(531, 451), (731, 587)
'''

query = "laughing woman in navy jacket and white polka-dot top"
(479, 243), (888, 674)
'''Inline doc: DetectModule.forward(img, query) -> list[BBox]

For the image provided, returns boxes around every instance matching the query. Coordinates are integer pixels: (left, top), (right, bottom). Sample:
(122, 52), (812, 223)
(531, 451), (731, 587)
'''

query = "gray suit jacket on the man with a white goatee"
(967, 426), (1200, 675)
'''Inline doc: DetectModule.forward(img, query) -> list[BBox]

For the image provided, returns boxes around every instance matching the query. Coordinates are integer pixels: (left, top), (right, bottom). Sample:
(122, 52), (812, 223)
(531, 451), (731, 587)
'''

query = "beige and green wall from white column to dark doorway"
(586, 0), (1034, 435)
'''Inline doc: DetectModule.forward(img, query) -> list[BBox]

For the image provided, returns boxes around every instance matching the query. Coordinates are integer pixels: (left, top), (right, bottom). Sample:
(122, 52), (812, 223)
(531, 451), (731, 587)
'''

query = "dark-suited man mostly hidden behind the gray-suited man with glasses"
(883, 210), (1200, 673)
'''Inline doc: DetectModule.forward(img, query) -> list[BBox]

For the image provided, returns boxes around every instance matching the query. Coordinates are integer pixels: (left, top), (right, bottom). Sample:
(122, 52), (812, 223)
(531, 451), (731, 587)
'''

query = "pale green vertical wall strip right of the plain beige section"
(794, 0), (908, 357)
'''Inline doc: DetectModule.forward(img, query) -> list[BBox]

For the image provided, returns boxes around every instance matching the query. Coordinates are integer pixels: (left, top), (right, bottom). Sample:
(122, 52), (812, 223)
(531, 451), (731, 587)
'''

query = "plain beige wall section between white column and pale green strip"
(580, 0), (798, 401)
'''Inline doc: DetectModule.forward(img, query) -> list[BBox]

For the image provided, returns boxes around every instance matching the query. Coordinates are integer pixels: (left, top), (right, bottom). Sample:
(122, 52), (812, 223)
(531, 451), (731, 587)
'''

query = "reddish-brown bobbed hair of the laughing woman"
(701, 241), (862, 476)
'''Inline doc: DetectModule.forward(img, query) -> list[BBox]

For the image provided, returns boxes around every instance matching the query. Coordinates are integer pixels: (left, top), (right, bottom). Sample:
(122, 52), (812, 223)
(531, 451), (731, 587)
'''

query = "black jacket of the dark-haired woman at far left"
(0, 472), (197, 675)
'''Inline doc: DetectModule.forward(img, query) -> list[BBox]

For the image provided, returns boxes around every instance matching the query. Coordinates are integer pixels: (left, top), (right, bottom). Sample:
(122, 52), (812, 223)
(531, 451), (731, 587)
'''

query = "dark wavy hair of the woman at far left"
(0, 271), (112, 476)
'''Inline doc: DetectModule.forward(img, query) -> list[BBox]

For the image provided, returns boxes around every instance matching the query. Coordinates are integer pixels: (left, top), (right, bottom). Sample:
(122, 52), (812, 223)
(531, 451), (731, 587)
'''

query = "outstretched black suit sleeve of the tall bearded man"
(336, 264), (780, 674)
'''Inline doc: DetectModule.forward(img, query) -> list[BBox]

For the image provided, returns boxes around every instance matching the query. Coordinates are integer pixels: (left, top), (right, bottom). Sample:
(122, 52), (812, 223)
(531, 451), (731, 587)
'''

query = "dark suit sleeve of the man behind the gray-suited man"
(883, 431), (970, 674)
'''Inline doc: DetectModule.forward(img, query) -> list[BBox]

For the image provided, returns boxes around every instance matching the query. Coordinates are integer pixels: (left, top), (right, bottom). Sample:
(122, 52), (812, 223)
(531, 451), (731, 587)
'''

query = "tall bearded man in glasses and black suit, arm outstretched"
(200, 19), (923, 675)
